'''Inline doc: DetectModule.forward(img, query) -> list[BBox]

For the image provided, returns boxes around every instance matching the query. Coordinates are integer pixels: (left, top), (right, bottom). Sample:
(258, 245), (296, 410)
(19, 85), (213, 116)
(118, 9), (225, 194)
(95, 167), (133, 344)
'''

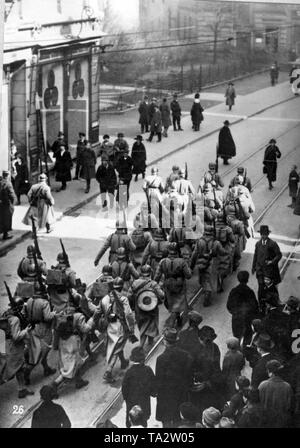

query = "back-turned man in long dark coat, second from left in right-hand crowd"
(155, 328), (192, 428)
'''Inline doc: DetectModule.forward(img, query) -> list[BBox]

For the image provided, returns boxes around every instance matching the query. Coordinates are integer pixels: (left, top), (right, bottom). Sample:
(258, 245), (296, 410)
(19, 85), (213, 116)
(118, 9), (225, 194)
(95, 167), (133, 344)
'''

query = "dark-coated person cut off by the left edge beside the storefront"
(0, 171), (16, 240)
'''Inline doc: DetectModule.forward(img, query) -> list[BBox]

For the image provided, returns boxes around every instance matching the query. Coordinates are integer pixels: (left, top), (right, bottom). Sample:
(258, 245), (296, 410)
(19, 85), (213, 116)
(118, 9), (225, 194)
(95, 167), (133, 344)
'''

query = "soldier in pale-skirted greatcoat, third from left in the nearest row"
(53, 294), (100, 389)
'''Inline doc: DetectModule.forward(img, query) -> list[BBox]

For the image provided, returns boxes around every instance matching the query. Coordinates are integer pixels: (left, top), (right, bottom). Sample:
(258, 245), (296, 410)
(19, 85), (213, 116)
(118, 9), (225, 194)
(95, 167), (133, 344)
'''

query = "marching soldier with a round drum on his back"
(128, 264), (164, 347)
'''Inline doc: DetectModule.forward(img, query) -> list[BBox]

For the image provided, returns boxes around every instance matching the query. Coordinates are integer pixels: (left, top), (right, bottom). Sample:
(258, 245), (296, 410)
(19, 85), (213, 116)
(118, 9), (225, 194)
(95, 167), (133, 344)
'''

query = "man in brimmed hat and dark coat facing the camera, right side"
(252, 225), (282, 301)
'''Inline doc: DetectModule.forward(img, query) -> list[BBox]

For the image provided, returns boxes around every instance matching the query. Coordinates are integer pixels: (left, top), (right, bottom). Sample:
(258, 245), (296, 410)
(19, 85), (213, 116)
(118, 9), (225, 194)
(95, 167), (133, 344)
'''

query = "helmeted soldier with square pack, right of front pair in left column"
(47, 253), (76, 311)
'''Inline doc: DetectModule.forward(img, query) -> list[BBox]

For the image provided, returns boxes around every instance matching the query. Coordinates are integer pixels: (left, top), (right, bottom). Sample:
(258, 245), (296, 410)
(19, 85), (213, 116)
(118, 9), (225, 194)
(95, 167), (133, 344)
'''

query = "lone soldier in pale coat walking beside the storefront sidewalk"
(22, 173), (55, 233)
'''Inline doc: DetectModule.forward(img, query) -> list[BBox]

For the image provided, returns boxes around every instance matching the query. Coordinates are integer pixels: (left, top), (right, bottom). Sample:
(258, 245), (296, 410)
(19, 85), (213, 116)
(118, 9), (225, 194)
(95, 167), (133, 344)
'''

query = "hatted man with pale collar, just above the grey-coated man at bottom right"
(251, 333), (276, 389)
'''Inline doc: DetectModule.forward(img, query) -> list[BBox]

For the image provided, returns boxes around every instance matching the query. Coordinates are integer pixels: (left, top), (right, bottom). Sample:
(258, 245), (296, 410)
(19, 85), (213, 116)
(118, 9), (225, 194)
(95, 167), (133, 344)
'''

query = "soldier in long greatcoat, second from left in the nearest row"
(25, 291), (56, 385)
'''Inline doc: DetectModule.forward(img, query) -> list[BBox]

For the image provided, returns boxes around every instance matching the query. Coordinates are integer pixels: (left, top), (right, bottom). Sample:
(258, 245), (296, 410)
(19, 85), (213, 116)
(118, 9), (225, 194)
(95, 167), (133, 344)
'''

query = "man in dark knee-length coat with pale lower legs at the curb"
(96, 156), (117, 208)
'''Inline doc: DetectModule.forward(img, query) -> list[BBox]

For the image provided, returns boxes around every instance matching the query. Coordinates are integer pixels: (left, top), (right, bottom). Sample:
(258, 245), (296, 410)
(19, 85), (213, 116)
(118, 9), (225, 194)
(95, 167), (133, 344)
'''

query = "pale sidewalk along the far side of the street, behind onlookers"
(0, 81), (295, 256)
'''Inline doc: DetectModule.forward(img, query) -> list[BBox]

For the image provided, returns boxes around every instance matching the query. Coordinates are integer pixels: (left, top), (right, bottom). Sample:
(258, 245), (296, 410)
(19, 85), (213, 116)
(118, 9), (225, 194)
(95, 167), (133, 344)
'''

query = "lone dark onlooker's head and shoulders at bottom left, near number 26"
(31, 386), (72, 428)
